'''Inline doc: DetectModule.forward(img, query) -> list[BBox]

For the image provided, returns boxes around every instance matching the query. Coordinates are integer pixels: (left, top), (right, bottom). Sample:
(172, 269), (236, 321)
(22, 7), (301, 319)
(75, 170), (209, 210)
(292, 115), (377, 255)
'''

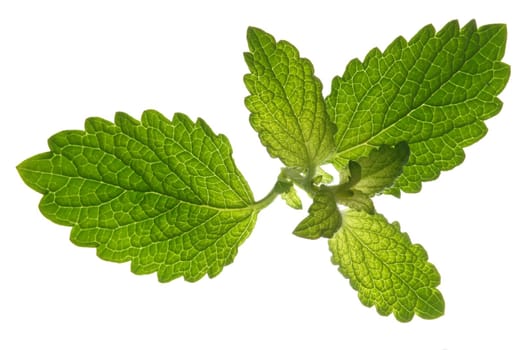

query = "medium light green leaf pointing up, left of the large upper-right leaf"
(244, 27), (334, 171)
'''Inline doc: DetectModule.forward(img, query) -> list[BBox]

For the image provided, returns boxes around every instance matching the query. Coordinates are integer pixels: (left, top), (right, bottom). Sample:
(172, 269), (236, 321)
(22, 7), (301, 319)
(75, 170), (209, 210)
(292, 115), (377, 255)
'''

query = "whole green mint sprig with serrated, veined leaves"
(17, 21), (510, 322)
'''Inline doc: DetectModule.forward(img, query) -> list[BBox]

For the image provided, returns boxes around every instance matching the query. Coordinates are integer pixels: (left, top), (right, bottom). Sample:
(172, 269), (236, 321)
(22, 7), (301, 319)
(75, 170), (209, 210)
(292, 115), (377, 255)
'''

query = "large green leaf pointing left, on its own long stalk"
(18, 110), (258, 282)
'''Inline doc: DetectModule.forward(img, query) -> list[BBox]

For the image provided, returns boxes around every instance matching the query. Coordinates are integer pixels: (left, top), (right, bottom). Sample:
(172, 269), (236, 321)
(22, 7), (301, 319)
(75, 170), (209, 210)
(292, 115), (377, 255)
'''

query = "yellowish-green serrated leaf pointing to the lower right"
(329, 210), (445, 322)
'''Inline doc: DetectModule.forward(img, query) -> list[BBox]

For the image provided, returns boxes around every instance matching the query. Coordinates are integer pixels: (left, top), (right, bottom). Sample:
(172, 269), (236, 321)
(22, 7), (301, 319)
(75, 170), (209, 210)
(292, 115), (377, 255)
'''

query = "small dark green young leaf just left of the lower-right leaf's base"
(293, 186), (341, 239)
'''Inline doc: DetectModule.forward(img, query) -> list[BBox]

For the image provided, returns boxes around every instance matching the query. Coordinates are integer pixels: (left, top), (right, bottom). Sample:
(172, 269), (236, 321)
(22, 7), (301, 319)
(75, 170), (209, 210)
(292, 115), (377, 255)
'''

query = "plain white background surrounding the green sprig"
(0, 0), (523, 350)
